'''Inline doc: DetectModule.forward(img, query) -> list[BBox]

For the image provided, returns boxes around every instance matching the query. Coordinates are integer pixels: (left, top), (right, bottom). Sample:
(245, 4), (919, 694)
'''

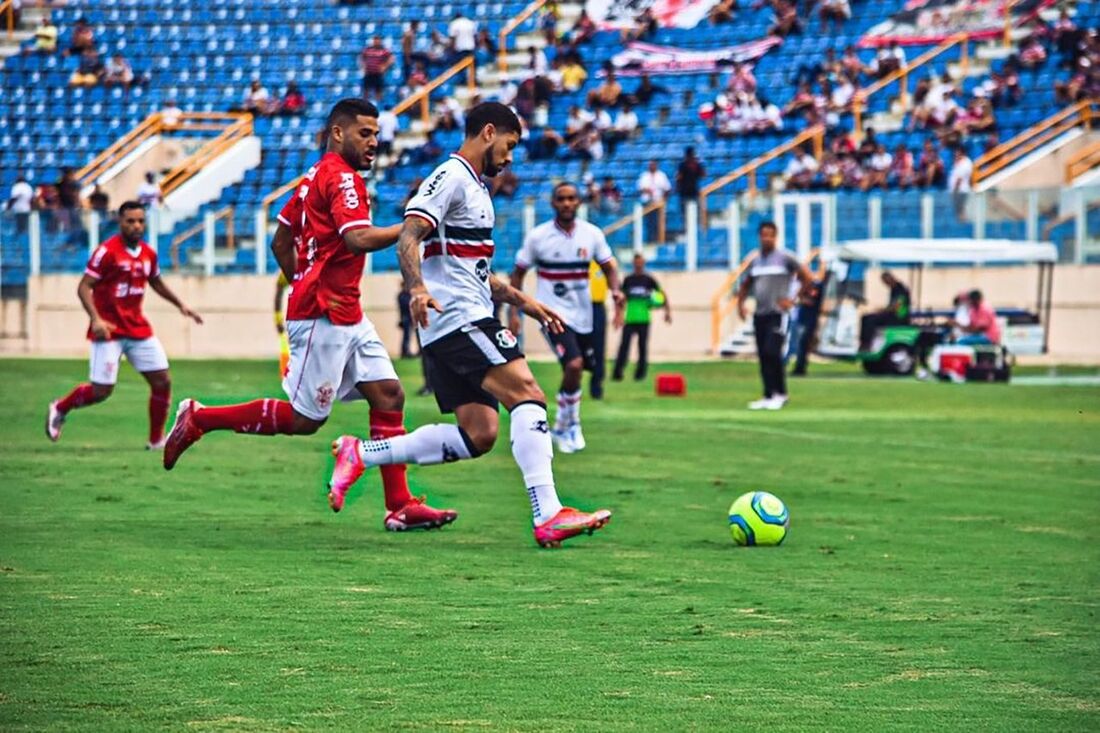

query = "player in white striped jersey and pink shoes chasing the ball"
(330, 102), (611, 547)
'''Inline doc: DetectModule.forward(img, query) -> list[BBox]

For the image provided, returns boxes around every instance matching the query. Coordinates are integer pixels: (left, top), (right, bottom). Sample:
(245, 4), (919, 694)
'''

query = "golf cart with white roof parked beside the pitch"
(817, 239), (1057, 380)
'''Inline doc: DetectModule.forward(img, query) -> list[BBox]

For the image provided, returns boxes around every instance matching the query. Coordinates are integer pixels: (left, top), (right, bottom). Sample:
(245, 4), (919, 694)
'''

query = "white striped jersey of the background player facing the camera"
(516, 219), (612, 333)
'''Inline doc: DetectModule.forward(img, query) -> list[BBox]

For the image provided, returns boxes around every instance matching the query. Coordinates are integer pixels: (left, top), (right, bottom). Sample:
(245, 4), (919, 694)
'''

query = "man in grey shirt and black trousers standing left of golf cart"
(737, 221), (813, 409)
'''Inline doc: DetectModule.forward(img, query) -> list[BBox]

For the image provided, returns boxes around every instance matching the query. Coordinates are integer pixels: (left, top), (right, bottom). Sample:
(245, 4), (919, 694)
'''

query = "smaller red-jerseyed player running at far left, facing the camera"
(46, 201), (202, 450)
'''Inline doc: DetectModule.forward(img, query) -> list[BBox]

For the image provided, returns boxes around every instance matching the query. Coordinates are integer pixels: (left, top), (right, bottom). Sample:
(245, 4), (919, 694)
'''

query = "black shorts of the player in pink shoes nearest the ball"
(424, 318), (524, 413)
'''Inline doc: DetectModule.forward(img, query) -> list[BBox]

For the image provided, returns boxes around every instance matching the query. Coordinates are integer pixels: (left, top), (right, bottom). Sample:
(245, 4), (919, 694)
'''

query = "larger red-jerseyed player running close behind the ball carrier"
(164, 99), (458, 532)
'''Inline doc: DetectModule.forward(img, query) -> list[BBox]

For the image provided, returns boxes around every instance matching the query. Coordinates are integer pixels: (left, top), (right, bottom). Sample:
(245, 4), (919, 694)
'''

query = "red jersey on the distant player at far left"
(84, 234), (161, 341)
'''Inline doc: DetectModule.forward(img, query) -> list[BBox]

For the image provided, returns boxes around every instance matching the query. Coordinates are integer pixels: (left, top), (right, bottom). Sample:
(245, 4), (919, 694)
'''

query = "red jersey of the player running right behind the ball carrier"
(279, 153), (371, 326)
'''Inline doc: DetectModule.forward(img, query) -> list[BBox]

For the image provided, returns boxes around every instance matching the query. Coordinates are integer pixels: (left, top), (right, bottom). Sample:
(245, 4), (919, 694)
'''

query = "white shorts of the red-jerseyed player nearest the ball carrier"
(283, 318), (397, 420)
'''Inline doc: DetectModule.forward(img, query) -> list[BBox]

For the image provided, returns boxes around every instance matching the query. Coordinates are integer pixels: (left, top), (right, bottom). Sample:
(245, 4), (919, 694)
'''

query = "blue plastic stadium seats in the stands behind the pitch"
(0, 0), (1100, 287)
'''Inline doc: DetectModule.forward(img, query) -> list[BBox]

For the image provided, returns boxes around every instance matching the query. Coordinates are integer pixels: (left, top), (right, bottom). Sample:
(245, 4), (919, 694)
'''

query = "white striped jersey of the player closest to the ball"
(405, 154), (496, 344)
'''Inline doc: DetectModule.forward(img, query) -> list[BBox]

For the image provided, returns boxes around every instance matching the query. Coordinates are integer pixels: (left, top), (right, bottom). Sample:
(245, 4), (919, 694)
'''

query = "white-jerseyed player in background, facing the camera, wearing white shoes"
(509, 183), (626, 453)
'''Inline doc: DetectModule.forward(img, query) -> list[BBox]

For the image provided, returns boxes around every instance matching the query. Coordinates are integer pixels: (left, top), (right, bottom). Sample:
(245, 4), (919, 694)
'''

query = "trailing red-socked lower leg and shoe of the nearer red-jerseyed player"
(164, 398), (301, 471)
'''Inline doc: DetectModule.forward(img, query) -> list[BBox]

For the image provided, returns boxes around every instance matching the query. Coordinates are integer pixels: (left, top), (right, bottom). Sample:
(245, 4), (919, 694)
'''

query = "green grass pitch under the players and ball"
(0, 360), (1100, 731)
